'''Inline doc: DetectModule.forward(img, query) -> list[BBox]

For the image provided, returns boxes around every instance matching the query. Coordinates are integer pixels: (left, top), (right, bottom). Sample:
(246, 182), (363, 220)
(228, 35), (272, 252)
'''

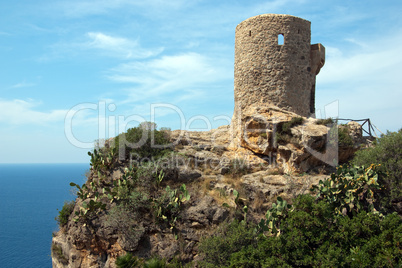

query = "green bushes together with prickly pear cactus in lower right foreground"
(199, 163), (402, 268)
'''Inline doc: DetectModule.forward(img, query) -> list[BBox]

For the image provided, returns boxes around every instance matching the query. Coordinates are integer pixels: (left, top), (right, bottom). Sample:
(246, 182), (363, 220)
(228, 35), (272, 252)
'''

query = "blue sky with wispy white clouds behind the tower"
(0, 0), (402, 163)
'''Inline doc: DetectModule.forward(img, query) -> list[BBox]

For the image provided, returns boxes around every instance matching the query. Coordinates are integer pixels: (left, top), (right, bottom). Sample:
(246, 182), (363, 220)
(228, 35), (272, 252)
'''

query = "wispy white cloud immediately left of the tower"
(109, 53), (233, 102)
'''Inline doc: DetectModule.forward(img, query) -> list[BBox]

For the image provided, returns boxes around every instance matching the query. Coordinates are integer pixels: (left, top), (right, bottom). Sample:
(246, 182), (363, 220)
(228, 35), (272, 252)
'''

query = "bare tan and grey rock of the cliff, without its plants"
(52, 119), (370, 267)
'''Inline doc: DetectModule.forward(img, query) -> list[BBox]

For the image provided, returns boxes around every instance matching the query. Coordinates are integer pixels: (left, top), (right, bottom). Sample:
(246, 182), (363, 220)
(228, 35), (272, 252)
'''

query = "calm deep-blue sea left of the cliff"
(0, 164), (89, 268)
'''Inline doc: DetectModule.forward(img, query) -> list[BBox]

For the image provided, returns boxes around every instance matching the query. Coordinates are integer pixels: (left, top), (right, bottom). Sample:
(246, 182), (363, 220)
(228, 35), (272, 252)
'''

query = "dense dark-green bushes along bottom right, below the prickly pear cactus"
(200, 195), (402, 267)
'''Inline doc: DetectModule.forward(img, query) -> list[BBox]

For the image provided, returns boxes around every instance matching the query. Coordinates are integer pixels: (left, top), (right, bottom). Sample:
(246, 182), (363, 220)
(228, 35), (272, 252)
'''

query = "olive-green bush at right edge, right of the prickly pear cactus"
(352, 129), (402, 207)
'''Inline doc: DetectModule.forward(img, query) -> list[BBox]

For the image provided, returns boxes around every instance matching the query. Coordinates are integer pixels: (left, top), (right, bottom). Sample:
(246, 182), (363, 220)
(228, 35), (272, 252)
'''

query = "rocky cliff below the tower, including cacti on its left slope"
(52, 110), (365, 267)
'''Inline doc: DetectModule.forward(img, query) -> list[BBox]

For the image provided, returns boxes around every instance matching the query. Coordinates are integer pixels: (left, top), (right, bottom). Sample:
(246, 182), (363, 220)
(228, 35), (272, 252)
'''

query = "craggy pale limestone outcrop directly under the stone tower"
(229, 105), (366, 172)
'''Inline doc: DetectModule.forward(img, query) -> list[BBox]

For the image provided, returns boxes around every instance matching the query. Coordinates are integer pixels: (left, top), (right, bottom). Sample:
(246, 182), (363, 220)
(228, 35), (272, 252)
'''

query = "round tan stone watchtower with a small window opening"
(234, 14), (325, 119)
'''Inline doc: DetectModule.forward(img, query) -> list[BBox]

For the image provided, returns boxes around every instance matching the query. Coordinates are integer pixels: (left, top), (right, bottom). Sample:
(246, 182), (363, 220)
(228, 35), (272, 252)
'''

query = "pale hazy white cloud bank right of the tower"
(316, 33), (402, 131)
